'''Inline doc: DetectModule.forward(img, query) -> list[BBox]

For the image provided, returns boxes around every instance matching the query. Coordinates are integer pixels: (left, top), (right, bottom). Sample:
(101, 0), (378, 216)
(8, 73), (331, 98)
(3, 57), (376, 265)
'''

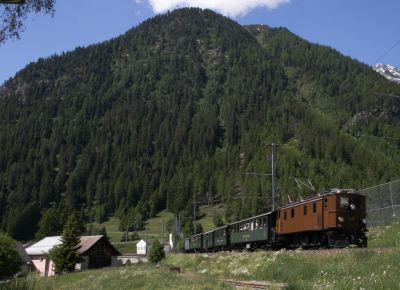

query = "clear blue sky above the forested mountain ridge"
(0, 0), (400, 84)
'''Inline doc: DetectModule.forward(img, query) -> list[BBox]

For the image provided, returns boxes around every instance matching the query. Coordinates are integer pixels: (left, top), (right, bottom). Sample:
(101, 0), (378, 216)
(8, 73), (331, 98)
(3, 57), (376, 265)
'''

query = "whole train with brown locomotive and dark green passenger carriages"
(184, 189), (368, 253)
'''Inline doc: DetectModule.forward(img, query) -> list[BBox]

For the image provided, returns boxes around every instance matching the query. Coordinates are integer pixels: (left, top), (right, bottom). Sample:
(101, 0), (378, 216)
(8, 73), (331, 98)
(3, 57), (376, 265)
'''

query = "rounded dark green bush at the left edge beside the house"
(0, 233), (22, 280)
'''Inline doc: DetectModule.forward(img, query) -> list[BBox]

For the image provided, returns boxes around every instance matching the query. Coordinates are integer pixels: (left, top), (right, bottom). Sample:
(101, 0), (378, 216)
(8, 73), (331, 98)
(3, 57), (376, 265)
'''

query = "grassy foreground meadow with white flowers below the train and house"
(0, 223), (400, 290)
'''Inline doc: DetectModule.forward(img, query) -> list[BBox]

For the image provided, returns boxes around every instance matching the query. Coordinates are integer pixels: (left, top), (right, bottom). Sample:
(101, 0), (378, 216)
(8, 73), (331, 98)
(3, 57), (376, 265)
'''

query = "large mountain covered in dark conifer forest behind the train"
(0, 8), (400, 240)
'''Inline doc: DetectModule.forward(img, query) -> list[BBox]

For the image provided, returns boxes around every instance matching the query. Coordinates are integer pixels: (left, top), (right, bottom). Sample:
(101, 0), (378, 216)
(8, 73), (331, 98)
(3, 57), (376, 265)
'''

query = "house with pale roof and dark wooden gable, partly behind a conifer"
(25, 235), (121, 277)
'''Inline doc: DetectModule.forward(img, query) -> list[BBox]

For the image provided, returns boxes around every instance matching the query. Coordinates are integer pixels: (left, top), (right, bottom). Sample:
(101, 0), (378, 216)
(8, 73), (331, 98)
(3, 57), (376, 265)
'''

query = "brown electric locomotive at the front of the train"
(275, 189), (367, 247)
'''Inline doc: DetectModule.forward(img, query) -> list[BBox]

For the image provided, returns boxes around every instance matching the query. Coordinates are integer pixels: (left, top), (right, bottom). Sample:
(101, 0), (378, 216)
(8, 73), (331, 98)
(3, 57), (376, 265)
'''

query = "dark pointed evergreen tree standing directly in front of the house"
(49, 215), (83, 274)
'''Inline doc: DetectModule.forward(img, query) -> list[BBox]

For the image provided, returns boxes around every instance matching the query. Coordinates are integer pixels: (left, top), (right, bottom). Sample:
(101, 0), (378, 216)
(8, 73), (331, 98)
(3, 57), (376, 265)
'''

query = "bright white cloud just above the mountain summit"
(148, 0), (290, 16)
